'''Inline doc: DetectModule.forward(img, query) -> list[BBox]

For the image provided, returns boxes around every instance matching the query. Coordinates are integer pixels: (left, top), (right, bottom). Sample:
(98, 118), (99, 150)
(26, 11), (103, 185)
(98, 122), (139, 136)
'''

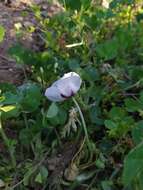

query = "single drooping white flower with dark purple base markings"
(45, 72), (82, 102)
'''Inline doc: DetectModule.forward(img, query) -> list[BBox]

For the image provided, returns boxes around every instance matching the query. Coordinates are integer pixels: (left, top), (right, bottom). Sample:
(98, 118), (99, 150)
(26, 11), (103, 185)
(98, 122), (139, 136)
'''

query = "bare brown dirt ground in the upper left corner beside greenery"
(0, 0), (60, 85)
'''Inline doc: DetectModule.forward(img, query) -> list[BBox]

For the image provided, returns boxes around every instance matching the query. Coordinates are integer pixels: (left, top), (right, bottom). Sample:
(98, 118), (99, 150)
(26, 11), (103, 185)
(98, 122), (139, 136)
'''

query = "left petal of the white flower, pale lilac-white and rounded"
(45, 86), (65, 102)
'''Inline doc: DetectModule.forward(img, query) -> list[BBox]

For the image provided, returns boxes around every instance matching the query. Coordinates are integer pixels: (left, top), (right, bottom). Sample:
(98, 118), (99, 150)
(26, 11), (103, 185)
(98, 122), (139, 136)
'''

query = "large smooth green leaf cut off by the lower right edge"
(122, 143), (143, 186)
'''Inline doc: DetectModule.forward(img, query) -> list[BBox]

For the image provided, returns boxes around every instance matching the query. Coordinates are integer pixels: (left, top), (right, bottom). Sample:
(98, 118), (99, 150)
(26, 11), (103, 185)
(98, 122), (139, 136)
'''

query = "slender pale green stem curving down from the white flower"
(72, 97), (90, 149)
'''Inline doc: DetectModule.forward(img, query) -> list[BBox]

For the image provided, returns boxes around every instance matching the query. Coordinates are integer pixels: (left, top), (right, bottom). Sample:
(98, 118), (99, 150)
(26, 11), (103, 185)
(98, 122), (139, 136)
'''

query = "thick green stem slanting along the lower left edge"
(0, 115), (16, 168)
